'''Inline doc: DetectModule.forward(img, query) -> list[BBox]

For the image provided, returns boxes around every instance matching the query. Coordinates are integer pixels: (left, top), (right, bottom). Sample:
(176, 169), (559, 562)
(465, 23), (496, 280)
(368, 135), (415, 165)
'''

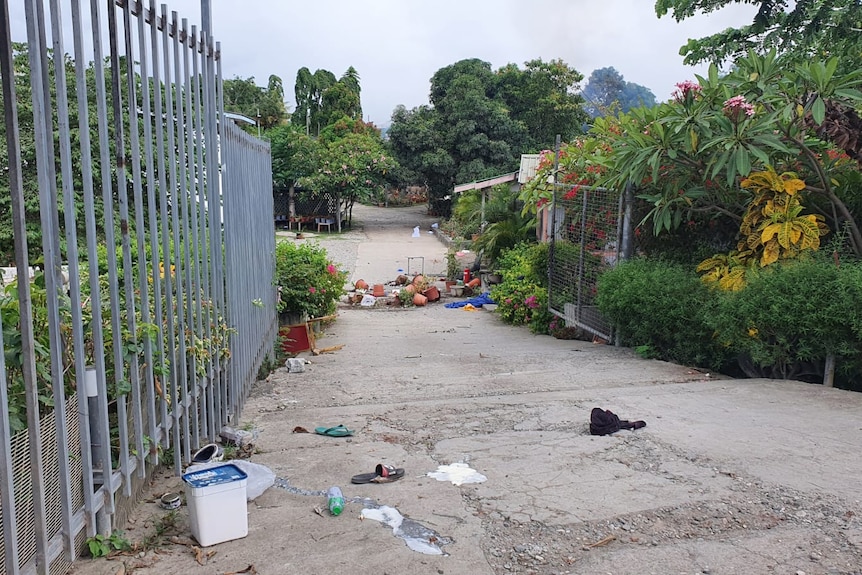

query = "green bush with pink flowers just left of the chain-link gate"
(491, 242), (553, 333)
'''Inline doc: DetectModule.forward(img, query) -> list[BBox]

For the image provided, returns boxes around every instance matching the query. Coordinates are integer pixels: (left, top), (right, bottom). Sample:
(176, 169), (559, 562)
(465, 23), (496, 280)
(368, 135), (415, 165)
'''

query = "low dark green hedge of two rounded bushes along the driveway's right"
(597, 258), (862, 389)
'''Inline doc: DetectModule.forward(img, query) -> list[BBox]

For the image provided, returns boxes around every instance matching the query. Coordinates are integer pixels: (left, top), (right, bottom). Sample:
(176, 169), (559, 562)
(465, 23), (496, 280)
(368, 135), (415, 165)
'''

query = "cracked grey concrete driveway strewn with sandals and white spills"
(73, 208), (862, 575)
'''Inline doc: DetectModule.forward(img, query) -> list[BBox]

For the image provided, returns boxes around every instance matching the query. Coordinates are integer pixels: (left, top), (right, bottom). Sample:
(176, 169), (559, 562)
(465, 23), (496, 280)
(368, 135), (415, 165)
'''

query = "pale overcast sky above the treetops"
(11, 0), (755, 126)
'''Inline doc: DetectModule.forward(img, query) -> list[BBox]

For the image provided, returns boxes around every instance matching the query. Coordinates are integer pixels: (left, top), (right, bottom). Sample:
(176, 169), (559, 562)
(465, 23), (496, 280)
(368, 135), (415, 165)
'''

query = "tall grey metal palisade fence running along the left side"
(0, 0), (277, 574)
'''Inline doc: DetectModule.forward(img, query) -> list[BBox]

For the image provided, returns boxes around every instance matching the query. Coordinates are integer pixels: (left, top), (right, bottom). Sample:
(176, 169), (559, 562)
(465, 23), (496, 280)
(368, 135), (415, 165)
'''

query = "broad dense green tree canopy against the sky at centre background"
(388, 59), (586, 215)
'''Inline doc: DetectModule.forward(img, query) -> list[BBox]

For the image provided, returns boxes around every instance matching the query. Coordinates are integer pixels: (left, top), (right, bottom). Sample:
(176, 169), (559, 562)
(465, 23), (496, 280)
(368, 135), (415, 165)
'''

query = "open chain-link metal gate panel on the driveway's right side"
(552, 184), (630, 342)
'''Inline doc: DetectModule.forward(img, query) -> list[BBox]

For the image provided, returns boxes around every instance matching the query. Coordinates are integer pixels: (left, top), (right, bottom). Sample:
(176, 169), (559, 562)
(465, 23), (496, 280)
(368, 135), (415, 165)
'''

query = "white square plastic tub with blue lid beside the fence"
(183, 463), (248, 547)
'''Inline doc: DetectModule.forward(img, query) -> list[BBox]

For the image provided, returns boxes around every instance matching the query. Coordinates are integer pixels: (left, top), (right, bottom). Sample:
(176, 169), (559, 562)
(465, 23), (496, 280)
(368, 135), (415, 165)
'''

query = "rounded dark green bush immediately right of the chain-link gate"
(596, 259), (727, 369)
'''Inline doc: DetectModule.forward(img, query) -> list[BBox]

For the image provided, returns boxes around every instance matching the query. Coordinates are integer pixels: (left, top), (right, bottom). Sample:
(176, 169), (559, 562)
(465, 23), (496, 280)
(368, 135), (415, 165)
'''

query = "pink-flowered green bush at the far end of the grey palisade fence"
(275, 242), (347, 317)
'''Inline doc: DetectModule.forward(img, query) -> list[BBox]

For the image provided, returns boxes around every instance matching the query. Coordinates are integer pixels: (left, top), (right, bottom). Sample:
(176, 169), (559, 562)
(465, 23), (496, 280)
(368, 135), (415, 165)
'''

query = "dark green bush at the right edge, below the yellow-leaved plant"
(709, 258), (862, 382)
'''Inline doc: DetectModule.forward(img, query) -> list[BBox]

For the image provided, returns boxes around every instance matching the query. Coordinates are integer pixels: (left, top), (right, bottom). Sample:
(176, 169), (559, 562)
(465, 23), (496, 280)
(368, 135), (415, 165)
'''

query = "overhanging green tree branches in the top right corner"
(655, 0), (862, 72)
